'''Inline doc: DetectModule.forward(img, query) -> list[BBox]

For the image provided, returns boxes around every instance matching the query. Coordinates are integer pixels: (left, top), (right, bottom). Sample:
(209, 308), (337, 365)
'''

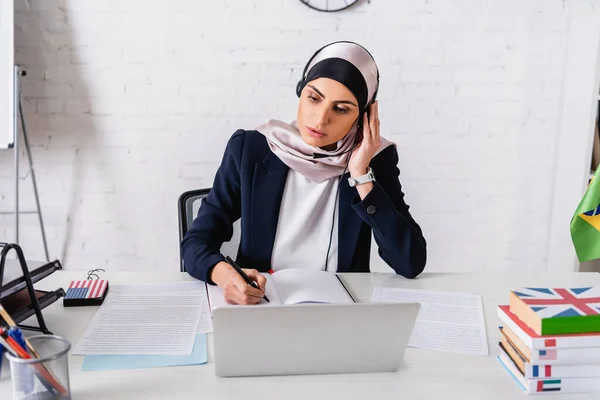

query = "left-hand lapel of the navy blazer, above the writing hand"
(250, 151), (289, 265)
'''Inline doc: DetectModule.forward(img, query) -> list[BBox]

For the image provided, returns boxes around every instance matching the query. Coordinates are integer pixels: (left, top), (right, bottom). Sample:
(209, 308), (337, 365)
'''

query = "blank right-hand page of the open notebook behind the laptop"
(272, 269), (354, 304)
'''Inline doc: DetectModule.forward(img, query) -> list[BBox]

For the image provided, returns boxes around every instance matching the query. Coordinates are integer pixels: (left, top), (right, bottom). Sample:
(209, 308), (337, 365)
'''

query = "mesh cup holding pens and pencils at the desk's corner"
(6, 335), (71, 400)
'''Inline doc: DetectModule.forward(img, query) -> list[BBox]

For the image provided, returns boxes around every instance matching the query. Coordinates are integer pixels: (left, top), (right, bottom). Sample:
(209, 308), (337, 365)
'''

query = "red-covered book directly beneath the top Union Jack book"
(497, 305), (600, 350)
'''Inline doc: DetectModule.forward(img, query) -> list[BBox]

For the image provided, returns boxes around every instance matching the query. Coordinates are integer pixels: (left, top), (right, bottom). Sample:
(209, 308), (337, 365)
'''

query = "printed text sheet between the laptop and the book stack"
(371, 287), (489, 355)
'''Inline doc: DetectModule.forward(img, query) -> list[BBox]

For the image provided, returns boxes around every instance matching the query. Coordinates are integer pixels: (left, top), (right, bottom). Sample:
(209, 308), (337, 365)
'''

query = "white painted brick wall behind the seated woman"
(0, 0), (580, 271)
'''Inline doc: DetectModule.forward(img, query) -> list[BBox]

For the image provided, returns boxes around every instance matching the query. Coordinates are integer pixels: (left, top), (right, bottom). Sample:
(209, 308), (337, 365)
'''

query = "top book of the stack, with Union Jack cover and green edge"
(510, 287), (600, 336)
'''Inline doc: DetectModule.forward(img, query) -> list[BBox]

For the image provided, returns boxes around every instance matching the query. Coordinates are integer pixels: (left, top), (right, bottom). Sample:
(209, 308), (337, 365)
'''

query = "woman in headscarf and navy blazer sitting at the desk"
(182, 42), (426, 304)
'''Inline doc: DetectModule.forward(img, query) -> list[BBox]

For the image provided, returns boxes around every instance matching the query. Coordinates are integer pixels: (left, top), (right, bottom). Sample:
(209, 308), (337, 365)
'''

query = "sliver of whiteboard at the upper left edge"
(0, 0), (15, 149)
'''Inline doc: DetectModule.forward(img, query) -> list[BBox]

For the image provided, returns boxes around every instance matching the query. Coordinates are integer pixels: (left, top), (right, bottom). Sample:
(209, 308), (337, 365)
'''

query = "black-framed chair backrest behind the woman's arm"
(177, 189), (241, 272)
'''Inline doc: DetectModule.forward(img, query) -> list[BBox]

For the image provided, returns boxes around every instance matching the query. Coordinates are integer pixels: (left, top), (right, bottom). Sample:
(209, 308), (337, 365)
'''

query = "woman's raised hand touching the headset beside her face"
(348, 101), (381, 177)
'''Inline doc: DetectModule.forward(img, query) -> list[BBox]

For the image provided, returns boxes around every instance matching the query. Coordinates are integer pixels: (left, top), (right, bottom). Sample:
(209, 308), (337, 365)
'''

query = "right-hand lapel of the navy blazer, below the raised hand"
(338, 173), (362, 272)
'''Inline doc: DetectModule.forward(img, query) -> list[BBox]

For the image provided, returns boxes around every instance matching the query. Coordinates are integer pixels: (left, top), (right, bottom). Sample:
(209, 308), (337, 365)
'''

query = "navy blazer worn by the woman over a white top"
(181, 130), (427, 284)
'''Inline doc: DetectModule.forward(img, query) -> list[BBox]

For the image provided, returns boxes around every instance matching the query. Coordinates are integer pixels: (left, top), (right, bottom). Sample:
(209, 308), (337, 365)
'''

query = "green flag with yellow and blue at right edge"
(571, 168), (600, 262)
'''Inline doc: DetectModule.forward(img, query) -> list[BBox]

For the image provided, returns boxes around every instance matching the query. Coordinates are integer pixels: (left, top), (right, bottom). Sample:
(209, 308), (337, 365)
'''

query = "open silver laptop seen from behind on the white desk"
(213, 303), (420, 377)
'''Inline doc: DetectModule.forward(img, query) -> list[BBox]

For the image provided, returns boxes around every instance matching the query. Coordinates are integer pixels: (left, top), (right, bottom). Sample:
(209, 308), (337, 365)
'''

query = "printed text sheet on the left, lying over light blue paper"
(73, 281), (206, 355)
